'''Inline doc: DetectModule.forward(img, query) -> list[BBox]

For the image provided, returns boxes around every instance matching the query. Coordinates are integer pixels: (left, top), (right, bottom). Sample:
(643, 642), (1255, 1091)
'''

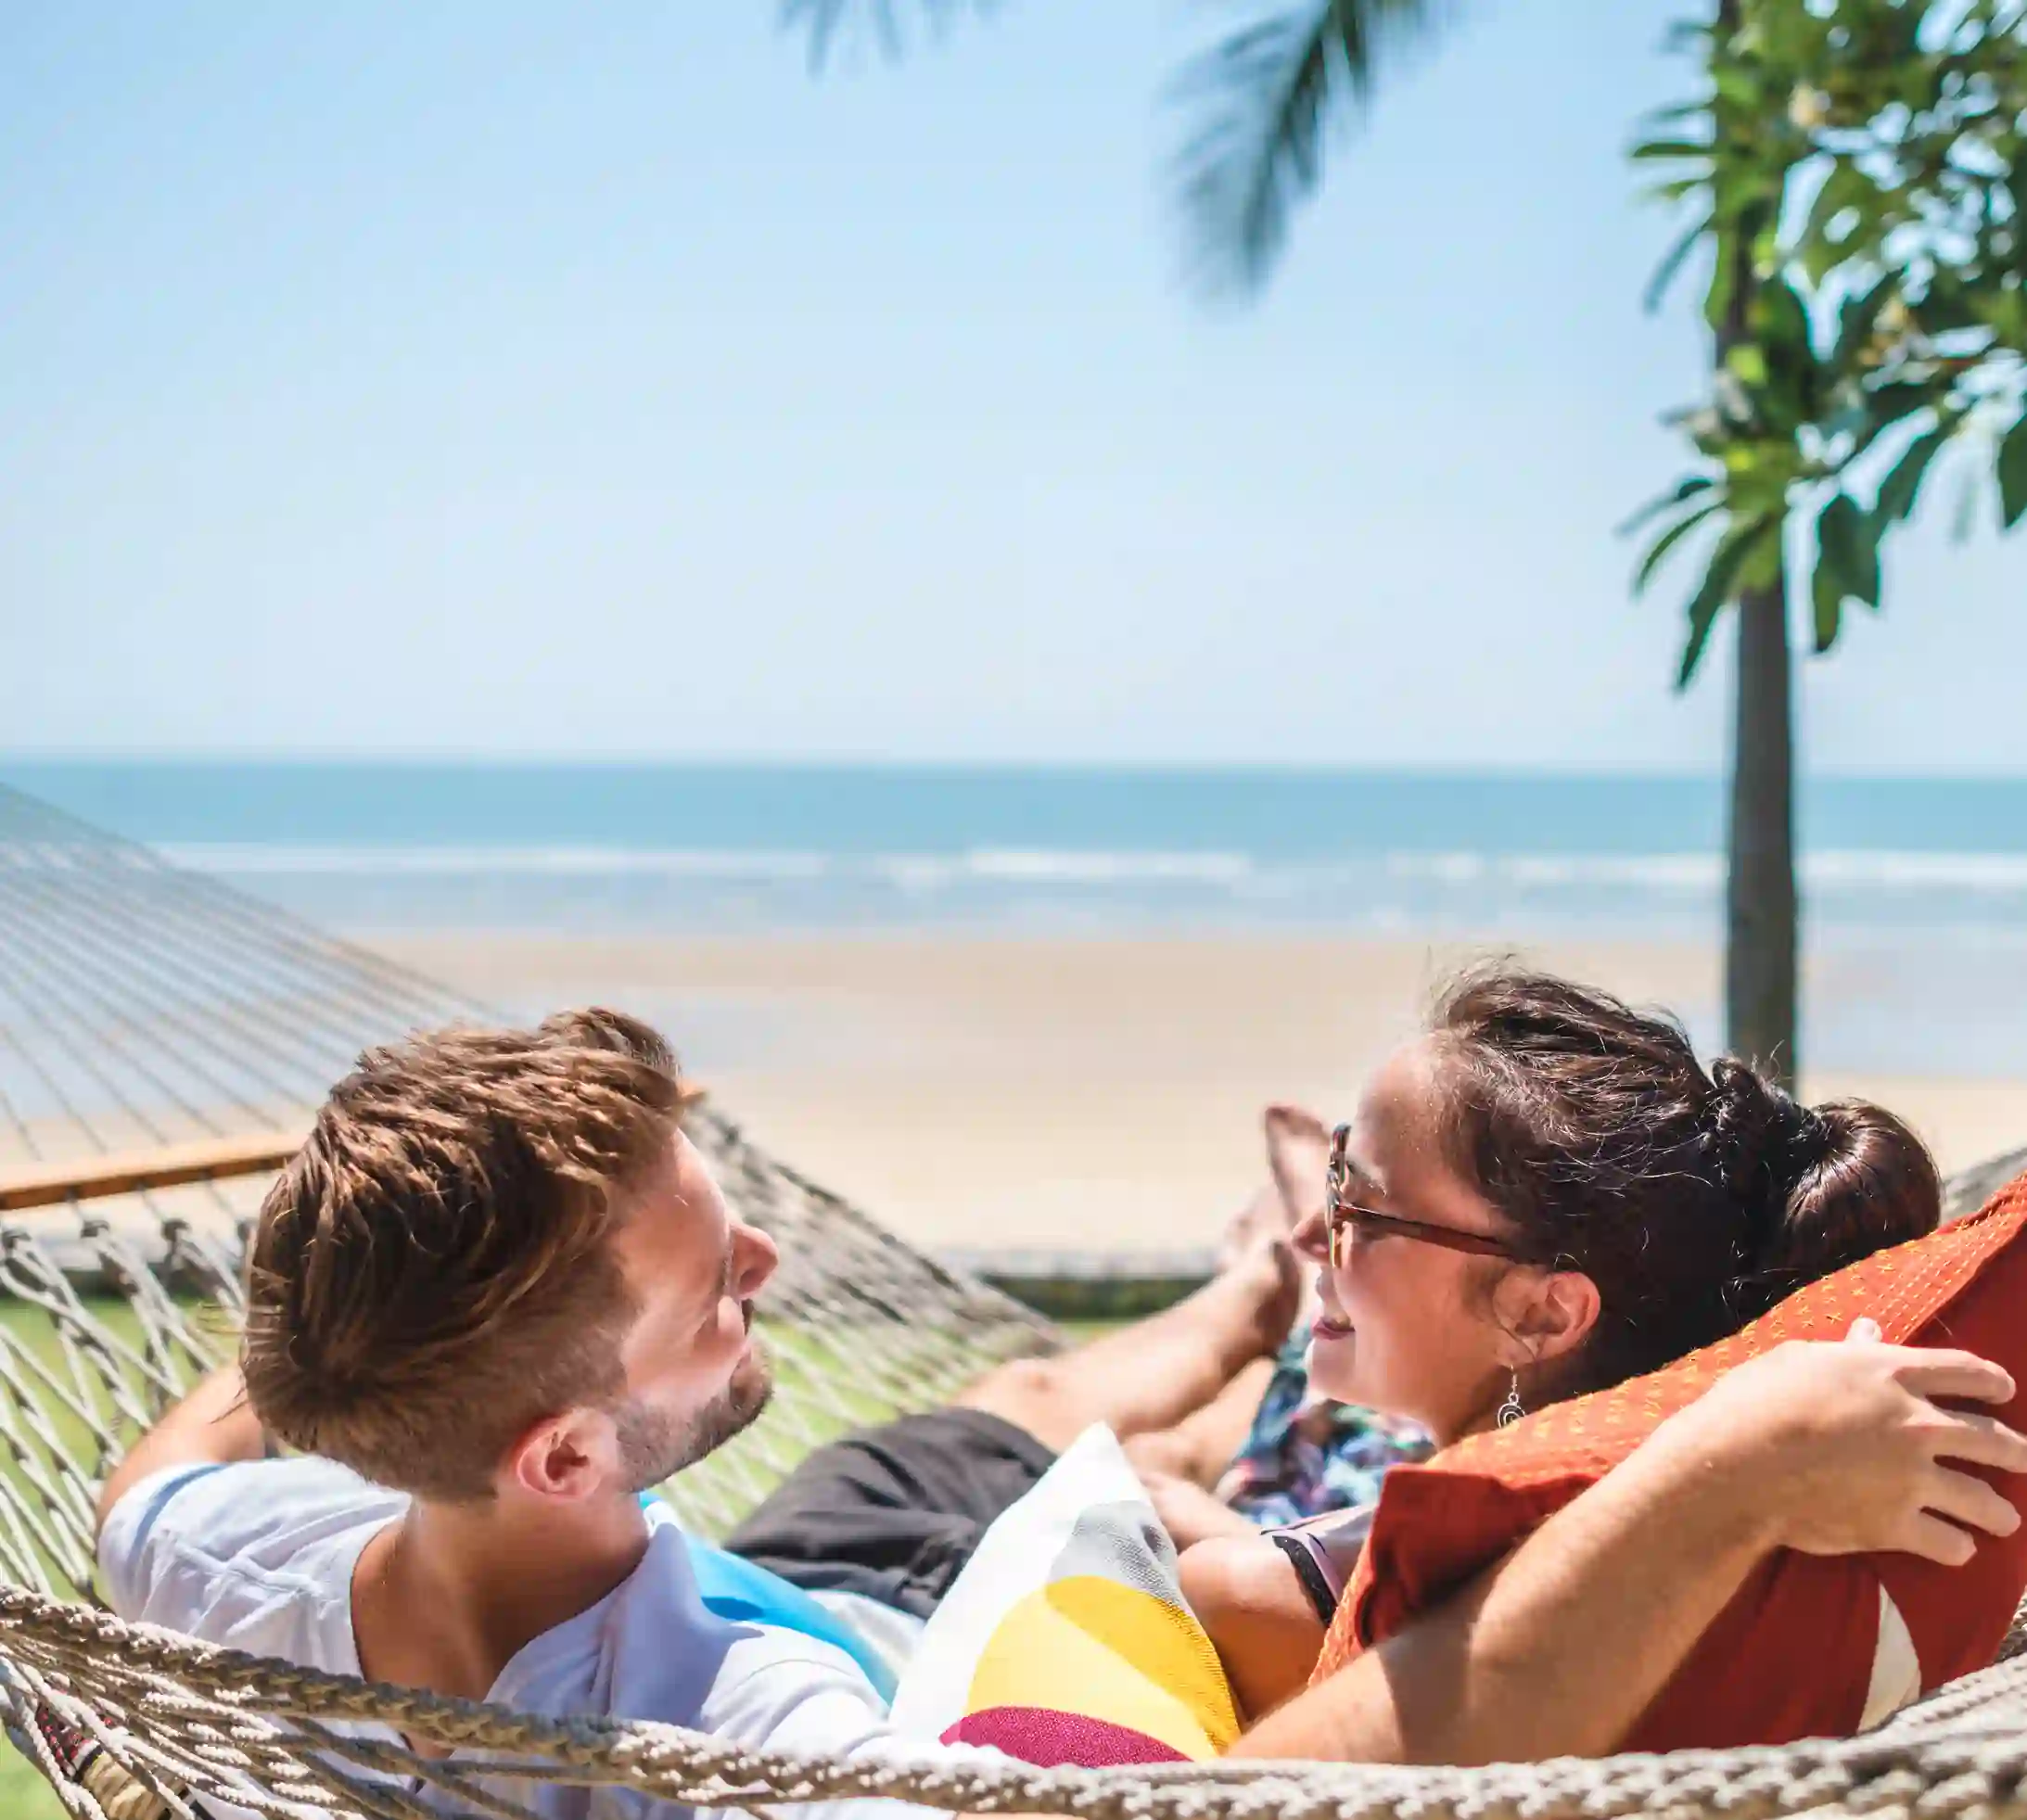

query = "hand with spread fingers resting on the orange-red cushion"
(1650, 1321), (2027, 1567)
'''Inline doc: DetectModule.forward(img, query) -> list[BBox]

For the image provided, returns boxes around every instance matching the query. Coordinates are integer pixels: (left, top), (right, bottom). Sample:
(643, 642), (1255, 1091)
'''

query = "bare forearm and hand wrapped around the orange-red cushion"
(1232, 1343), (2027, 1763)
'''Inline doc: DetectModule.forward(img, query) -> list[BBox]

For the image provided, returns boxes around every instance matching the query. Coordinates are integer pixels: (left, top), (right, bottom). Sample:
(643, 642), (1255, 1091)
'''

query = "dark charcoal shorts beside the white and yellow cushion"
(726, 1408), (1056, 1617)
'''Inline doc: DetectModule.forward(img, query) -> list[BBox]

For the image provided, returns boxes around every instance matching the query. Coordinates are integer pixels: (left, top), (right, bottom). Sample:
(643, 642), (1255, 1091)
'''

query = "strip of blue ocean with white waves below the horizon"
(0, 760), (2027, 948)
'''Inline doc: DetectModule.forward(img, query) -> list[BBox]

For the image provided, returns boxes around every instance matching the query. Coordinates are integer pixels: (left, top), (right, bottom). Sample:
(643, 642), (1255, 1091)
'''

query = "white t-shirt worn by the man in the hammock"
(99, 1459), (975, 1820)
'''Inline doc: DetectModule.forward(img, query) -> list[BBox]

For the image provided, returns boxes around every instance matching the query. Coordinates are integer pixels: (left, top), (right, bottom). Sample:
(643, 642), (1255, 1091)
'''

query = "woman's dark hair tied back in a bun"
(1431, 969), (1942, 1394)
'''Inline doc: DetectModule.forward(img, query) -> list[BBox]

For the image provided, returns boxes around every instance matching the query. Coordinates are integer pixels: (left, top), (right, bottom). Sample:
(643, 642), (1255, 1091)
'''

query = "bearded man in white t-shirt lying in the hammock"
(99, 1012), (2027, 1816)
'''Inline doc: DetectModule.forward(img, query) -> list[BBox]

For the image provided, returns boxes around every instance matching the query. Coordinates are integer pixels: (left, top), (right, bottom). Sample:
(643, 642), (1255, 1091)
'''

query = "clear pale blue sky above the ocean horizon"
(0, 0), (2027, 772)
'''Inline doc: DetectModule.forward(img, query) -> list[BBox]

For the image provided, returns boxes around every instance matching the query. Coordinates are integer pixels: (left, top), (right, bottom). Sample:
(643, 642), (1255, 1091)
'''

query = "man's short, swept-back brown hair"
(241, 1010), (687, 1500)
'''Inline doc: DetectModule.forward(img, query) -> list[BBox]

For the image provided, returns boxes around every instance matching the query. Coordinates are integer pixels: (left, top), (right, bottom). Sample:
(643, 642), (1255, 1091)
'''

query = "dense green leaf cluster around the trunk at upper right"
(1634, 0), (2027, 681)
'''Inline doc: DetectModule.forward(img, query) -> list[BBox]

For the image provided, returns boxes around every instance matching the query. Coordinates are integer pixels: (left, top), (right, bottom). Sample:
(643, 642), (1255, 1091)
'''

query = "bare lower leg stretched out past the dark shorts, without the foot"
(955, 1241), (1299, 1457)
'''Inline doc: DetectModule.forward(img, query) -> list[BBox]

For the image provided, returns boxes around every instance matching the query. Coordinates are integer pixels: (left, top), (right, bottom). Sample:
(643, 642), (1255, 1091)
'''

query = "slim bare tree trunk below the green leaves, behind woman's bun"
(1725, 581), (1798, 1090)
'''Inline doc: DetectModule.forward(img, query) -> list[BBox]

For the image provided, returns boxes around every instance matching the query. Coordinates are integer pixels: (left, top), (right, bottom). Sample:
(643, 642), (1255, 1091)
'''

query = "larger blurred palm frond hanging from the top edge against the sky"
(1176, 0), (1456, 292)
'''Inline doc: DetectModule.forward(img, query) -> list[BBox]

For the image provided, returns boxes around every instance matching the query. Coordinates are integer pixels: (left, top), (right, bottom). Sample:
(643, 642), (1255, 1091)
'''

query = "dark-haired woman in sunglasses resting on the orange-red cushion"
(1181, 971), (1942, 1714)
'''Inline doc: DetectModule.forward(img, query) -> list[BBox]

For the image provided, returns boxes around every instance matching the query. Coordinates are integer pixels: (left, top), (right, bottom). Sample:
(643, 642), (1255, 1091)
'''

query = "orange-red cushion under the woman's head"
(1316, 1176), (2027, 1751)
